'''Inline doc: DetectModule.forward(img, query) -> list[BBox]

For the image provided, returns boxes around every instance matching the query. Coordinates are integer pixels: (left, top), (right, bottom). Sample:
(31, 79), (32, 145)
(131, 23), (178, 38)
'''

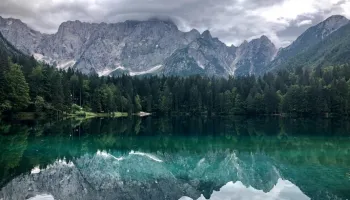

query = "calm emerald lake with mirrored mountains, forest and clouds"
(0, 117), (350, 200)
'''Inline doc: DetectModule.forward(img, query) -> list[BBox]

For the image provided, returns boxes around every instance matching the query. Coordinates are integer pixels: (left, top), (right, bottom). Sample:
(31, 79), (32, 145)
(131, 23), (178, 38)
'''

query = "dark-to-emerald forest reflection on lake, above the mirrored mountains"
(0, 117), (350, 198)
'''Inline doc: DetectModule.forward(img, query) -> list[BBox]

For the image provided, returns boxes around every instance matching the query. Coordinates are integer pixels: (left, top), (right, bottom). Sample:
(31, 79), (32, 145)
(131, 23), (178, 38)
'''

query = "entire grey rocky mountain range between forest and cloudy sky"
(0, 15), (350, 77)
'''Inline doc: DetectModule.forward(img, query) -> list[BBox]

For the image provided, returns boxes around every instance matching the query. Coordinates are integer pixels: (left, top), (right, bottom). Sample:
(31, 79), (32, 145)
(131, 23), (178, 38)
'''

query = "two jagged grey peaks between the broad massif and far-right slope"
(165, 31), (276, 76)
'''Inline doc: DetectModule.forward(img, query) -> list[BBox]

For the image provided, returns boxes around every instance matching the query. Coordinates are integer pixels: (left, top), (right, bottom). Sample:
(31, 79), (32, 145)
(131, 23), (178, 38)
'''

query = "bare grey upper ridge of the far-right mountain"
(267, 15), (349, 70)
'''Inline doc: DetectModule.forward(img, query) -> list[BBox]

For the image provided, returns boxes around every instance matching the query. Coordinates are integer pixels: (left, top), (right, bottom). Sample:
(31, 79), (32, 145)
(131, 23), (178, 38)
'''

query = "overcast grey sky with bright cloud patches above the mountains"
(0, 0), (350, 47)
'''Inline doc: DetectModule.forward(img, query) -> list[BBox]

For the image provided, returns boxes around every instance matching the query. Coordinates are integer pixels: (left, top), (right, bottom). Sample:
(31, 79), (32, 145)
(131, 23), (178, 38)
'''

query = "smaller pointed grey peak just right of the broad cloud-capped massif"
(163, 31), (235, 76)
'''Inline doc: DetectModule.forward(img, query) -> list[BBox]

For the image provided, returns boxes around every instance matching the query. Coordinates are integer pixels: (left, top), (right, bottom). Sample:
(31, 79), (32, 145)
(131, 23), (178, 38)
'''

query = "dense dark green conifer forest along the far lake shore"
(0, 45), (350, 116)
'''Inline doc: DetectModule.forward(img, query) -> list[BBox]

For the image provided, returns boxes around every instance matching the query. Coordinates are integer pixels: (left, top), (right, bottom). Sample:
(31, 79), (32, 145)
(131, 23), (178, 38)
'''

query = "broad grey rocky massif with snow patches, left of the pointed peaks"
(0, 19), (200, 74)
